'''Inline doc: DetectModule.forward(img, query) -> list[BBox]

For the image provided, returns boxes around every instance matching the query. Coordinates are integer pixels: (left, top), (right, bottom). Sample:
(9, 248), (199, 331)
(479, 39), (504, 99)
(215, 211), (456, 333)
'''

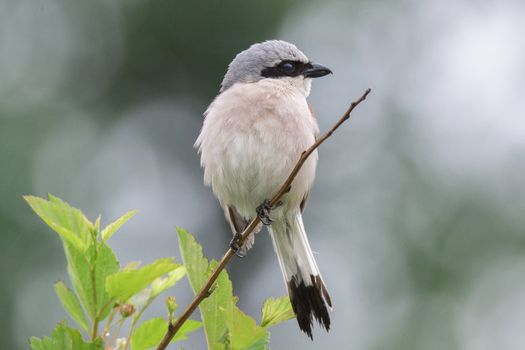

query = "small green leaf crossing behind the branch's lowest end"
(130, 317), (202, 350)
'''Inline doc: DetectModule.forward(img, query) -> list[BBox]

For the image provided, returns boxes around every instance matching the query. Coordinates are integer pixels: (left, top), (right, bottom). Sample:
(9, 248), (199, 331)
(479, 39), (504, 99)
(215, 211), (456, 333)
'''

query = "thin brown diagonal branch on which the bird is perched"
(157, 89), (371, 350)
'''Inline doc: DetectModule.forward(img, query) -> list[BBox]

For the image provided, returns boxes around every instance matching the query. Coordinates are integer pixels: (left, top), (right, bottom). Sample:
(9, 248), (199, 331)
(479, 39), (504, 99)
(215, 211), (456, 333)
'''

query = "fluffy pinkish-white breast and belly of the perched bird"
(196, 79), (318, 218)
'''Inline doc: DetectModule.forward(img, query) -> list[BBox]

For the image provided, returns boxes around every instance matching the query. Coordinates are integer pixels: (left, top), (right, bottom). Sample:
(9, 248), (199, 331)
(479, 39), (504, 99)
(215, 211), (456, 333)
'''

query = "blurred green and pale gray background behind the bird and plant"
(0, 0), (525, 350)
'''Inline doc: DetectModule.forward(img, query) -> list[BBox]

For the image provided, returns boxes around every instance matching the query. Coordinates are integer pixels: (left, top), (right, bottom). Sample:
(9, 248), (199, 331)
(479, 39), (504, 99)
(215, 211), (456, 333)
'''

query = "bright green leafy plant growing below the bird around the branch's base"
(24, 195), (294, 350)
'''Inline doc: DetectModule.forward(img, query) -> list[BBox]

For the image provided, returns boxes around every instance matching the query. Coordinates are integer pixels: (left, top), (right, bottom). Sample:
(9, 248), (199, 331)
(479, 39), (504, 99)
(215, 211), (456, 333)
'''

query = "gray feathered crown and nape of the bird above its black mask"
(220, 40), (308, 92)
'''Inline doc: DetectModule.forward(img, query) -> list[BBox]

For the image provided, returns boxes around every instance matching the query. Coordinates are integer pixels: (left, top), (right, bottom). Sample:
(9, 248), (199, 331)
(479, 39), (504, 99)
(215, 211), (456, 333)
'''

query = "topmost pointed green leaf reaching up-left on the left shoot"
(24, 195), (93, 251)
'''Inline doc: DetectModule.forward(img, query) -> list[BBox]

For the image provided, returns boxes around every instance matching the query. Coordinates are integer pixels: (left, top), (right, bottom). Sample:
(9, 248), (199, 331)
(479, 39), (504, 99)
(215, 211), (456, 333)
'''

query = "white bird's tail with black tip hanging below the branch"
(269, 210), (332, 338)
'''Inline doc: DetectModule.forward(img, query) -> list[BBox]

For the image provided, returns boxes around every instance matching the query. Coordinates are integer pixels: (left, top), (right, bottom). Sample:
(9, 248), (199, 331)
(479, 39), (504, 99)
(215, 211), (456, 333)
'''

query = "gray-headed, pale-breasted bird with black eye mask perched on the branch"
(195, 40), (332, 338)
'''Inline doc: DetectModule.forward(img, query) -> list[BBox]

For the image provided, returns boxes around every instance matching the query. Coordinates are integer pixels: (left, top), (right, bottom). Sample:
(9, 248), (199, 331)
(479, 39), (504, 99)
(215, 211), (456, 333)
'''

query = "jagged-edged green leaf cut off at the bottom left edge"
(30, 322), (104, 350)
